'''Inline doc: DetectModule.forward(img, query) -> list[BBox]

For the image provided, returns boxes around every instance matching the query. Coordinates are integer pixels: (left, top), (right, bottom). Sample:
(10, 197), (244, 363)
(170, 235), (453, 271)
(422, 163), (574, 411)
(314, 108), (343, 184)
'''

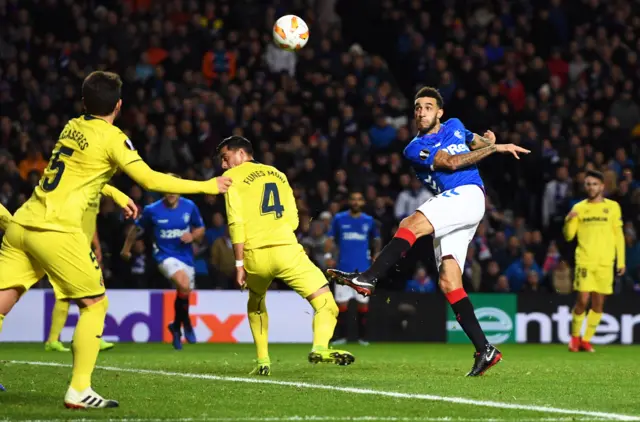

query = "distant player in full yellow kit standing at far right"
(563, 171), (625, 352)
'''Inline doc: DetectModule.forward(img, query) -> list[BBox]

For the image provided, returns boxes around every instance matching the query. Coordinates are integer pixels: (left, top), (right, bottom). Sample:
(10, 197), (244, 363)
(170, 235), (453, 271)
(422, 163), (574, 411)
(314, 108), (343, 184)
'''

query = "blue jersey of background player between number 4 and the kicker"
(328, 211), (380, 272)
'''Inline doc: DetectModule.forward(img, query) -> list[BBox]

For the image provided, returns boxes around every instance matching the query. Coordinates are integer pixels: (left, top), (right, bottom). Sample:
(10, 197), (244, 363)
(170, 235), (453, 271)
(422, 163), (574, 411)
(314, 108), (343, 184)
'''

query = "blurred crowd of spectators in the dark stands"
(0, 0), (640, 294)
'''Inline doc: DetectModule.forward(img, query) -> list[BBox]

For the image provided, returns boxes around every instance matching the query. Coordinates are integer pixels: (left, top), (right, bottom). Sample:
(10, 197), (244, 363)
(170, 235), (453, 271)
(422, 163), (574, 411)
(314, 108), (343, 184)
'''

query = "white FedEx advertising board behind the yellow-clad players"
(0, 290), (313, 343)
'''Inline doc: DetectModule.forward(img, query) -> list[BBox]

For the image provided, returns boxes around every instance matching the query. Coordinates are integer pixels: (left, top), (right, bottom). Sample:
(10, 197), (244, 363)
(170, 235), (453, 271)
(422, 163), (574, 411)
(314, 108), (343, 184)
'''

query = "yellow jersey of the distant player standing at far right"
(564, 199), (625, 268)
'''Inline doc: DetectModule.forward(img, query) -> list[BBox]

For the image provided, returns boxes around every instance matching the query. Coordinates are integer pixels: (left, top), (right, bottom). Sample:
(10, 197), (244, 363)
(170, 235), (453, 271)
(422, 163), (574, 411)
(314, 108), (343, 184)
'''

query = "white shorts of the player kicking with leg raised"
(418, 185), (485, 271)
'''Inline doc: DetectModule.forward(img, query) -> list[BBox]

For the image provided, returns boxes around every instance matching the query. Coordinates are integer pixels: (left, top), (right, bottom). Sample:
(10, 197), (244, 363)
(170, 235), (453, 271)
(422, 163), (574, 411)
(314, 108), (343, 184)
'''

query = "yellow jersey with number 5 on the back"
(14, 115), (141, 232)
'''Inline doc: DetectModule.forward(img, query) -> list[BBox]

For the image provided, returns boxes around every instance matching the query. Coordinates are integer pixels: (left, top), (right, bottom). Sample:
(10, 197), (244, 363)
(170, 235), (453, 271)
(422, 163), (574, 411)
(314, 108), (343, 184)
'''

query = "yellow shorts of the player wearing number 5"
(0, 223), (105, 299)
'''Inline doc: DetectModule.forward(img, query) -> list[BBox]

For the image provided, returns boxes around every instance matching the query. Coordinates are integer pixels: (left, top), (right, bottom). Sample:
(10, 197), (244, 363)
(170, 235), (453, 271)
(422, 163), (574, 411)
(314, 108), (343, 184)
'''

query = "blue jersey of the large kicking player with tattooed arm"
(404, 119), (484, 195)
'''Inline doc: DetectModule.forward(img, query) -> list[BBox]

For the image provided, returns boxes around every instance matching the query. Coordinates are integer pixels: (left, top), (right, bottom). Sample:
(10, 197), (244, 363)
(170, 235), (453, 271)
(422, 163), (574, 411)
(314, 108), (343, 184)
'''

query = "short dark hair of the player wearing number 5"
(82, 70), (122, 116)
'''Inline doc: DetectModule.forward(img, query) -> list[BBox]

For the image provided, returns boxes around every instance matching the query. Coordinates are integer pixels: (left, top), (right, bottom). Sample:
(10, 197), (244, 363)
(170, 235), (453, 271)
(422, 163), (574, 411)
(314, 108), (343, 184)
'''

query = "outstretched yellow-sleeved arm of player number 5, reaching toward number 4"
(123, 160), (231, 195)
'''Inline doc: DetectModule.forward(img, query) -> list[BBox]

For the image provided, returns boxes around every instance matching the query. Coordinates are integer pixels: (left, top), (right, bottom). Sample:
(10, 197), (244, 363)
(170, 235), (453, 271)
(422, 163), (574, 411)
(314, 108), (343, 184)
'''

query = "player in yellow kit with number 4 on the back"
(217, 136), (354, 375)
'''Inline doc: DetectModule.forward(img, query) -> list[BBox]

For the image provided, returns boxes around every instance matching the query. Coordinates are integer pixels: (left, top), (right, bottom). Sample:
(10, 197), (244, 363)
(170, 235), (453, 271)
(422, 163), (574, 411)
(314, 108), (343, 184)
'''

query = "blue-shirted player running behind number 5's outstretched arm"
(121, 174), (205, 350)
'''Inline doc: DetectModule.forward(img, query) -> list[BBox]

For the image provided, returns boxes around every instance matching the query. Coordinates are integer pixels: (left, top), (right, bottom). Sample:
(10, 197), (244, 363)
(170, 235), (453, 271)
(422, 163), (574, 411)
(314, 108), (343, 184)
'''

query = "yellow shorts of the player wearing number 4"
(244, 244), (328, 298)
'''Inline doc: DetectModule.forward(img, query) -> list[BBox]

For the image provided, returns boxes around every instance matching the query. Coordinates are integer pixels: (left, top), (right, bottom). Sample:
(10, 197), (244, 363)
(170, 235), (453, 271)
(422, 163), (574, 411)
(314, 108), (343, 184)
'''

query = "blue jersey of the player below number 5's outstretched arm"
(136, 198), (204, 267)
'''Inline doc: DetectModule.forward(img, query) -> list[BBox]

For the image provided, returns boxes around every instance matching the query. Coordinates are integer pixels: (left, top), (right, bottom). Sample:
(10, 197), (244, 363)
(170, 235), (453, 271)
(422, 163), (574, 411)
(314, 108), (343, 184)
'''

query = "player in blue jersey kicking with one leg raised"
(328, 87), (530, 376)
